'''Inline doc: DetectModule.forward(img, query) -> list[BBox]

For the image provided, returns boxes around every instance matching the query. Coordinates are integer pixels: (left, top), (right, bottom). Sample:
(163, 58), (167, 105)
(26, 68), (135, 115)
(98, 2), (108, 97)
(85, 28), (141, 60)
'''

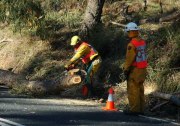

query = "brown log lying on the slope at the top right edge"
(159, 10), (180, 22)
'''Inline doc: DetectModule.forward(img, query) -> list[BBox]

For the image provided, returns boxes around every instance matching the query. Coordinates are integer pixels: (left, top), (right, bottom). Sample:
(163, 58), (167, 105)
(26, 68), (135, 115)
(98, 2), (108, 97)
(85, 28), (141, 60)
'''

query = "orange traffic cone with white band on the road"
(102, 88), (117, 111)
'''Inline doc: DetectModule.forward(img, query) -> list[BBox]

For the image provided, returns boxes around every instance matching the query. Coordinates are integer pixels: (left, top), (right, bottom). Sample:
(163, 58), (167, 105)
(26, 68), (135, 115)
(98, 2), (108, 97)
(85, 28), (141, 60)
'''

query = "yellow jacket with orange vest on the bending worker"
(70, 42), (98, 64)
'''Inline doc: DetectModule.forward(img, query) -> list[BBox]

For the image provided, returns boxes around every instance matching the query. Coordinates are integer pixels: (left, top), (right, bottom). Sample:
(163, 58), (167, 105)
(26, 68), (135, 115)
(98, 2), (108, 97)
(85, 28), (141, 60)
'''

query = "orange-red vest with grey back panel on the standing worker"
(131, 39), (147, 68)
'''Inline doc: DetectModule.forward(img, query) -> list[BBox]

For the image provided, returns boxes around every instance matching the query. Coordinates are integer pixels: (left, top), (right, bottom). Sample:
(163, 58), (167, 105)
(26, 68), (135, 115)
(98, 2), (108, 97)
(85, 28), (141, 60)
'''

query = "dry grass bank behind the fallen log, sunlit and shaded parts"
(0, 27), (69, 83)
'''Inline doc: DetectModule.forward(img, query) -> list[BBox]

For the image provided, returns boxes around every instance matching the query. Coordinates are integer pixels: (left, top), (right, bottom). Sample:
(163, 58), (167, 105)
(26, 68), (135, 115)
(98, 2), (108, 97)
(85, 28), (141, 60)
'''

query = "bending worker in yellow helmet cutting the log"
(65, 36), (101, 96)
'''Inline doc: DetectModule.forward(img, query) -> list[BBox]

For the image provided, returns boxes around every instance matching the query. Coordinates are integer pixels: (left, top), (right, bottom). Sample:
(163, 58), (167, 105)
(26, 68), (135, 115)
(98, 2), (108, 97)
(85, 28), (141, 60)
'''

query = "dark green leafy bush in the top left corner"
(0, 0), (45, 30)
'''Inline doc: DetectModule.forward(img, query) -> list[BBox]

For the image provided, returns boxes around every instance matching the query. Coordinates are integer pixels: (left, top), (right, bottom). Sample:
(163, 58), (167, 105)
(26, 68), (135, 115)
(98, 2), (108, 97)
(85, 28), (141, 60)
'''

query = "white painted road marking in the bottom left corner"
(0, 118), (25, 126)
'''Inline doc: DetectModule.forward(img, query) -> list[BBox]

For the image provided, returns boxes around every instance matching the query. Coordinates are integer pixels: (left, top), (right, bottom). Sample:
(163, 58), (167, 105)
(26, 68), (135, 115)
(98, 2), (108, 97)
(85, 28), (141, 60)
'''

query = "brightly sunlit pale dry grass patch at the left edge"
(0, 28), (49, 73)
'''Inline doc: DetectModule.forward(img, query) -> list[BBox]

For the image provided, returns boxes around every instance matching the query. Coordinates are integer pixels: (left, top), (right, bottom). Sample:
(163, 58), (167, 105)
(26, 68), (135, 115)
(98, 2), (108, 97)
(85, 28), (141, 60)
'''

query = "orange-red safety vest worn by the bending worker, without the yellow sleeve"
(75, 42), (98, 64)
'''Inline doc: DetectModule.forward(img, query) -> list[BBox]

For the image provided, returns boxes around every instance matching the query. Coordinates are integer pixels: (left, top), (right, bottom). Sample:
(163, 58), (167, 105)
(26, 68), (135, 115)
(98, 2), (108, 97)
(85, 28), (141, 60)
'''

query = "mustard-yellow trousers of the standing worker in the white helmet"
(127, 67), (147, 112)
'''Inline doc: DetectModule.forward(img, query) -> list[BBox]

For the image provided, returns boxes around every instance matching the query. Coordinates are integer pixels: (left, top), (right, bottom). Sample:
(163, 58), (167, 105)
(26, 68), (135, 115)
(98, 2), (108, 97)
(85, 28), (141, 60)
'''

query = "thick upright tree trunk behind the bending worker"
(81, 0), (105, 36)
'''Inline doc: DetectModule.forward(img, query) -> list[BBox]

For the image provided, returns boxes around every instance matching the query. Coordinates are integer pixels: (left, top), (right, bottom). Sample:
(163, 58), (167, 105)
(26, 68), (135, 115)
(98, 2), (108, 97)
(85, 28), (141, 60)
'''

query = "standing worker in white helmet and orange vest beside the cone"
(123, 22), (147, 115)
